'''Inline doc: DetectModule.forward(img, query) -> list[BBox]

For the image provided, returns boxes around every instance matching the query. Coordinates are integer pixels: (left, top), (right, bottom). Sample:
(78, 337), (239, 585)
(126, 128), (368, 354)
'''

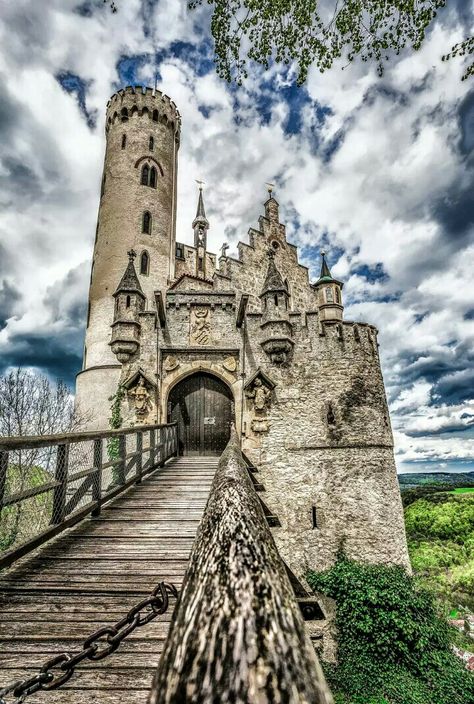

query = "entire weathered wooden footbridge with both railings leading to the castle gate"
(0, 425), (332, 704)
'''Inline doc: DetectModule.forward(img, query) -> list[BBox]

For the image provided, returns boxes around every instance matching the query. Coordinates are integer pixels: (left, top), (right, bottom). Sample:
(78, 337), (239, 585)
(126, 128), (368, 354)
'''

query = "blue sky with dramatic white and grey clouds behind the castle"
(0, 0), (474, 472)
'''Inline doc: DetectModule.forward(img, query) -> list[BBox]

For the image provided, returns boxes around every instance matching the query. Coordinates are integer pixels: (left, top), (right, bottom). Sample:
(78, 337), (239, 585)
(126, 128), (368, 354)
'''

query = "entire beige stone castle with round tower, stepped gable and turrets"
(76, 87), (409, 656)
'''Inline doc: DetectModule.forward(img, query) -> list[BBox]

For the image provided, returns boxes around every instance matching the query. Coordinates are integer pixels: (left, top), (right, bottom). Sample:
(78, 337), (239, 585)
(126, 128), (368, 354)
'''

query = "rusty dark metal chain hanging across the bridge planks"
(0, 582), (178, 704)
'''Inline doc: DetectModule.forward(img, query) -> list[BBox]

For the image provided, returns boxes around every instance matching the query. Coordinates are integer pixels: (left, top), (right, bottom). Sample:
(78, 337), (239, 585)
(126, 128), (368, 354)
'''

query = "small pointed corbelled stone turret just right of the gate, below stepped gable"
(260, 249), (294, 364)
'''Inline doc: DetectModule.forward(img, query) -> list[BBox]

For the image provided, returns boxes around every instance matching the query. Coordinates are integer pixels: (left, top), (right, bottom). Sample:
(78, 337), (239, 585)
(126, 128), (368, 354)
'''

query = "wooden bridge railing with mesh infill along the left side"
(0, 423), (178, 568)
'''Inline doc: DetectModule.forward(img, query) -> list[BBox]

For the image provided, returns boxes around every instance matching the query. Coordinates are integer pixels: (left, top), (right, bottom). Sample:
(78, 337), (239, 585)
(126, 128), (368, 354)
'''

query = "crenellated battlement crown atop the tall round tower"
(105, 86), (181, 136)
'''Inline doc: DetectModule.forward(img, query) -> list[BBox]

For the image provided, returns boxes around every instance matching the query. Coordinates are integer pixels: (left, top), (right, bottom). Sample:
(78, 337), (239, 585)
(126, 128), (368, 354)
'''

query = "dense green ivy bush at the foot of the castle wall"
(308, 554), (474, 704)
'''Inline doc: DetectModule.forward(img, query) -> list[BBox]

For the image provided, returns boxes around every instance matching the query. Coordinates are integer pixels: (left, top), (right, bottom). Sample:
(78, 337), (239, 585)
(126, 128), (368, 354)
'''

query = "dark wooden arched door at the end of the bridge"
(168, 372), (234, 455)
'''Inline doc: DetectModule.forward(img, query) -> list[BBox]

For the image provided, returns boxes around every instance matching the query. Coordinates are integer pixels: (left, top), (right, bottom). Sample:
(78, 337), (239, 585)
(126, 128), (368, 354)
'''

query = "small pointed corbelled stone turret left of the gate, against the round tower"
(110, 249), (146, 364)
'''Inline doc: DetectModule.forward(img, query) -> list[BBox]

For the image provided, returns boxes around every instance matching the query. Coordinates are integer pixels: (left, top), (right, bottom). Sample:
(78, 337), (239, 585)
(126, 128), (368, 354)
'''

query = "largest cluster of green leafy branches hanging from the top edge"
(189, 0), (458, 84)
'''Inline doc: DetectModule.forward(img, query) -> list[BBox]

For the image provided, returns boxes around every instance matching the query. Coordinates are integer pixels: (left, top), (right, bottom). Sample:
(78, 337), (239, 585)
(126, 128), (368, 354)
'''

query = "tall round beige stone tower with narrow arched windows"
(77, 86), (181, 427)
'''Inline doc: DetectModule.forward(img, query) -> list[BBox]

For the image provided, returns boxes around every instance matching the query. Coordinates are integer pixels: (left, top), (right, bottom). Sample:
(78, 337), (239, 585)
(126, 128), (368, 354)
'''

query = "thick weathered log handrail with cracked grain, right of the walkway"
(149, 431), (333, 704)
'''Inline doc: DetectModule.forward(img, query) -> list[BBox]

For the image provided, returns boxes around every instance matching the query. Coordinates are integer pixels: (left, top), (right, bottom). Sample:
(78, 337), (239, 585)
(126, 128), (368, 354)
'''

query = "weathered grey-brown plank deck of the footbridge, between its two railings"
(0, 458), (217, 704)
